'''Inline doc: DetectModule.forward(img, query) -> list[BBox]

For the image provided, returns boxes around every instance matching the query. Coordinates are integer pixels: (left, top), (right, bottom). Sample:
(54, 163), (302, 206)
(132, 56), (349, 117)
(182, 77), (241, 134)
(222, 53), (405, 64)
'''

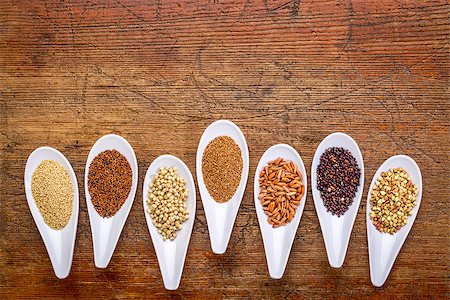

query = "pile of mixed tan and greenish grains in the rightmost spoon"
(370, 168), (418, 234)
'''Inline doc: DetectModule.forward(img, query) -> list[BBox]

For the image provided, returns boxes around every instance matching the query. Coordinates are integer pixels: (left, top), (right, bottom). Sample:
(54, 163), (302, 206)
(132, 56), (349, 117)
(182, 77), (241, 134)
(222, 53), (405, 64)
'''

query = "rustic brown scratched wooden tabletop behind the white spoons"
(0, 0), (450, 299)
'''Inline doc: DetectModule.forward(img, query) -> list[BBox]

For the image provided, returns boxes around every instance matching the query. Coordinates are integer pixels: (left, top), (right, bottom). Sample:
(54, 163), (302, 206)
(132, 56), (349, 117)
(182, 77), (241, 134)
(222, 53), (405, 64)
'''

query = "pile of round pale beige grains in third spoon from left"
(147, 167), (189, 241)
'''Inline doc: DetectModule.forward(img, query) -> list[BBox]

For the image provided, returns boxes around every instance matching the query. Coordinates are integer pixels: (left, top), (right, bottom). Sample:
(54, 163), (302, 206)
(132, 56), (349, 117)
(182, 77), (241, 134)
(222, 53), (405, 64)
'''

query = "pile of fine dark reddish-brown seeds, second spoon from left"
(88, 150), (133, 218)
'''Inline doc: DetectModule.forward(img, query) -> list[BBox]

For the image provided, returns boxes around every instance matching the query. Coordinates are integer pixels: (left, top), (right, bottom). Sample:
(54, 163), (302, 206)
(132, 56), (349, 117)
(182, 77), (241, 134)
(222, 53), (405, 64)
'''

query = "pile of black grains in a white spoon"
(317, 147), (361, 217)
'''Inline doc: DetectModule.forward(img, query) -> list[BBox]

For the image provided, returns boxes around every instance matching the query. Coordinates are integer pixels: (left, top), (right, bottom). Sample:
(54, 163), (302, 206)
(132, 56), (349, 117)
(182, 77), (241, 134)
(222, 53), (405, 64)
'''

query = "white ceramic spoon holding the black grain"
(311, 132), (364, 268)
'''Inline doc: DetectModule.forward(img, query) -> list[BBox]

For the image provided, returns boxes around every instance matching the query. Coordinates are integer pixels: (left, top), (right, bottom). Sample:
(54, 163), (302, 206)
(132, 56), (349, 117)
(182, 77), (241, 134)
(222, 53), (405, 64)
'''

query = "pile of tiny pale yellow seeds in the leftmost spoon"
(31, 160), (74, 230)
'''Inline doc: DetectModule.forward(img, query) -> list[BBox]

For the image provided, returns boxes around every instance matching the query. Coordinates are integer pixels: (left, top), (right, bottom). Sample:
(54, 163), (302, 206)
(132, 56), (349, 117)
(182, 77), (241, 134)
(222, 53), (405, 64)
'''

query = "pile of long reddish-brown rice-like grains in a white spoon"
(258, 158), (305, 228)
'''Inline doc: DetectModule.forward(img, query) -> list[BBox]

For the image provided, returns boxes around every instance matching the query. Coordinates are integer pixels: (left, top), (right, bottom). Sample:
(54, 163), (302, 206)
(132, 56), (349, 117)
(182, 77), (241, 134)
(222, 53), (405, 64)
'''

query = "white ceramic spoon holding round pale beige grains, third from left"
(142, 155), (196, 290)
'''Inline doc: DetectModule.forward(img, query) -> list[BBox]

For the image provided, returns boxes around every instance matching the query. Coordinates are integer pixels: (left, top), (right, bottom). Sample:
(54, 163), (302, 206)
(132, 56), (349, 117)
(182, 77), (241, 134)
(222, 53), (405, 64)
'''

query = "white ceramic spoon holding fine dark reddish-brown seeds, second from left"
(84, 134), (138, 268)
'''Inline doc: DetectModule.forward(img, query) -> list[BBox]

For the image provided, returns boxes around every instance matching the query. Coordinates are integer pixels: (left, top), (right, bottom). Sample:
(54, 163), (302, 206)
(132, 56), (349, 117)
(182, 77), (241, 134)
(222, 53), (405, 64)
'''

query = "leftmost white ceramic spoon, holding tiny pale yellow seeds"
(24, 147), (79, 279)
